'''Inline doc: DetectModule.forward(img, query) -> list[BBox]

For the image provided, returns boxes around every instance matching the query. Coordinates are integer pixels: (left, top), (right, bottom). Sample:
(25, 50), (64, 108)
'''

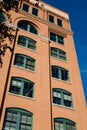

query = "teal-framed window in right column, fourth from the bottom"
(51, 47), (66, 61)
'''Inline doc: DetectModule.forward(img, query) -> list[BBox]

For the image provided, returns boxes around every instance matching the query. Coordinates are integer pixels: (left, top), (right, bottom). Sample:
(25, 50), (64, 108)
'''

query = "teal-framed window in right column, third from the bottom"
(52, 66), (69, 81)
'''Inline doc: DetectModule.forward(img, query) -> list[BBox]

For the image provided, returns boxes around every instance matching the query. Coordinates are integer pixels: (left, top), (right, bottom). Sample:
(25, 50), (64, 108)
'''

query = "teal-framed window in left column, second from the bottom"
(9, 77), (34, 98)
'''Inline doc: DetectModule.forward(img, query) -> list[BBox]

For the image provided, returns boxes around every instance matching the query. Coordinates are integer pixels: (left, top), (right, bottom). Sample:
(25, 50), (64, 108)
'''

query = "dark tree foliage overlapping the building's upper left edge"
(0, 0), (20, 66)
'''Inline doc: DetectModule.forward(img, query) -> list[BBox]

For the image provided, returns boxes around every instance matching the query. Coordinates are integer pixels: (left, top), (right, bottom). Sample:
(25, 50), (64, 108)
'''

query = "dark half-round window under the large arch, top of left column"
(18, 21), (38, 34)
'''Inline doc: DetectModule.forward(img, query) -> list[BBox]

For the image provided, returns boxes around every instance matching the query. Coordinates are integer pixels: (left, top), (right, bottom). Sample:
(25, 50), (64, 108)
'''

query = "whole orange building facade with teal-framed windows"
(0, 0), (87, 130)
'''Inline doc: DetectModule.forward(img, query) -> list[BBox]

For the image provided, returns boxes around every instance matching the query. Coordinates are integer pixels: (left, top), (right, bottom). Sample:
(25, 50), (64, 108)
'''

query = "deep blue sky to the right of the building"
(42, 0), (87, 102)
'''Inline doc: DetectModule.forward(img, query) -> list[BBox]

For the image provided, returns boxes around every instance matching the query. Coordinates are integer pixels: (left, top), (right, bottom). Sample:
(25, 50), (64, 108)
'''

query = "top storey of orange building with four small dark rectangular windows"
(11, 0), (71, 31)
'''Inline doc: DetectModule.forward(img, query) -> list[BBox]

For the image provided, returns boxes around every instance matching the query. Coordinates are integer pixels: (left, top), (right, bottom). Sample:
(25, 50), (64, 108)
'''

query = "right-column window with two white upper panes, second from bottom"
(53, 89), (73, 107)
